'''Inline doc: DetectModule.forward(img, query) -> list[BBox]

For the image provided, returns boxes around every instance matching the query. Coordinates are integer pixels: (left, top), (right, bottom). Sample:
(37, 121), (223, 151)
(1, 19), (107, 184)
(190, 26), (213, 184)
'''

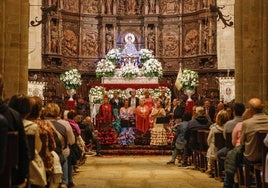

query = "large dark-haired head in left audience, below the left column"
(8, 95), (32, 119)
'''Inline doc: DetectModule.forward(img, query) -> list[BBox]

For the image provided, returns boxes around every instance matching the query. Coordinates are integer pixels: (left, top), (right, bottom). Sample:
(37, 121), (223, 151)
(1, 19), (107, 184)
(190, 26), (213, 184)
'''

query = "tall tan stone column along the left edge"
(0, 0), (29, 98)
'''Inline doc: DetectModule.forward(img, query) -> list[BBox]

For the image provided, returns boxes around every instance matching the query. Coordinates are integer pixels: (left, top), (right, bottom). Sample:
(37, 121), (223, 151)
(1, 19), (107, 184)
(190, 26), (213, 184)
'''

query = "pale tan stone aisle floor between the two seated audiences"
(74, 156), (223, 188)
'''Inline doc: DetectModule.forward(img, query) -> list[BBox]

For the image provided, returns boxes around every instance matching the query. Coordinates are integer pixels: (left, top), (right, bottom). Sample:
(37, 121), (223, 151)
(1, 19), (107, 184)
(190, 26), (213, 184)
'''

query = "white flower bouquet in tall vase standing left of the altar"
(60, 69), (82, 90)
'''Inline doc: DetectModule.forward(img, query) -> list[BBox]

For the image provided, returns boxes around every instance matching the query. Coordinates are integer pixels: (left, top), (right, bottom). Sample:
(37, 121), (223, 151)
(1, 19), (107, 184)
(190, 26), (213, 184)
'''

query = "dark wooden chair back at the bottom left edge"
(0, 131), (19, 188)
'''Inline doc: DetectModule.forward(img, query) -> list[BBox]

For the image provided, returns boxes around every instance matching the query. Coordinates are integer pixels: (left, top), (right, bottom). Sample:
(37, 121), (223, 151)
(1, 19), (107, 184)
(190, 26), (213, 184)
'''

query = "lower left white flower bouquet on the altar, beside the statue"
(96, 59), (115, 78)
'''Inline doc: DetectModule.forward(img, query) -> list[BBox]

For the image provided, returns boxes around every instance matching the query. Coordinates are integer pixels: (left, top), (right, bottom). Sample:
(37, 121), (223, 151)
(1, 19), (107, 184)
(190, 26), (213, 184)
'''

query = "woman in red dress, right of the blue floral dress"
(136, 98), (150, 133)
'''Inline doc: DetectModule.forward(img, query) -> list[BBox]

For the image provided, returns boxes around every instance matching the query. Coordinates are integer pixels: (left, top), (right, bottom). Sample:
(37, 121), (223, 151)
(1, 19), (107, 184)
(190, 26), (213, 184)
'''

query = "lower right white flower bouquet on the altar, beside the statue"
(141, 59), (163, 78)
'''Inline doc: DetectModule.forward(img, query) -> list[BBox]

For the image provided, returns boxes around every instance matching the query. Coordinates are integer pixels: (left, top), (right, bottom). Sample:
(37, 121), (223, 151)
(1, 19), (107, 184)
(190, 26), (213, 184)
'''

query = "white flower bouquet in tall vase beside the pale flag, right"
(181, 69), (198, 90)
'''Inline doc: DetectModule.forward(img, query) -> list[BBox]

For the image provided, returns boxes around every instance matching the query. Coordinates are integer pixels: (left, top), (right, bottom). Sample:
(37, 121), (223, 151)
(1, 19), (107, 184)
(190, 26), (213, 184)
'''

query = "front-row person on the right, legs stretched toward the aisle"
(167, 112), (192, 164)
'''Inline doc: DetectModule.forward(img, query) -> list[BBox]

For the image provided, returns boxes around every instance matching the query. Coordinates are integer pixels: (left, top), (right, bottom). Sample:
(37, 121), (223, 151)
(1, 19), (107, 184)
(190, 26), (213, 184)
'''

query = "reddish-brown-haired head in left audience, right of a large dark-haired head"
(27, 96), (43, 119)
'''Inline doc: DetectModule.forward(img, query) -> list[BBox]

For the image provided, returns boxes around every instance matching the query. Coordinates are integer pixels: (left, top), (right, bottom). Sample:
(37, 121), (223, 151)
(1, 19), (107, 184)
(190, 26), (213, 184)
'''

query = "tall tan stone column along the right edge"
(234, 0), (268, 104)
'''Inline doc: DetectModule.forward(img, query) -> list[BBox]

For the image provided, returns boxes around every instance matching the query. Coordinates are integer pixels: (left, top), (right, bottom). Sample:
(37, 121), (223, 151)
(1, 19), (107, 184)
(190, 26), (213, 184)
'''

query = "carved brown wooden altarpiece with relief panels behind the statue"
(29, 0), (232, 104)
